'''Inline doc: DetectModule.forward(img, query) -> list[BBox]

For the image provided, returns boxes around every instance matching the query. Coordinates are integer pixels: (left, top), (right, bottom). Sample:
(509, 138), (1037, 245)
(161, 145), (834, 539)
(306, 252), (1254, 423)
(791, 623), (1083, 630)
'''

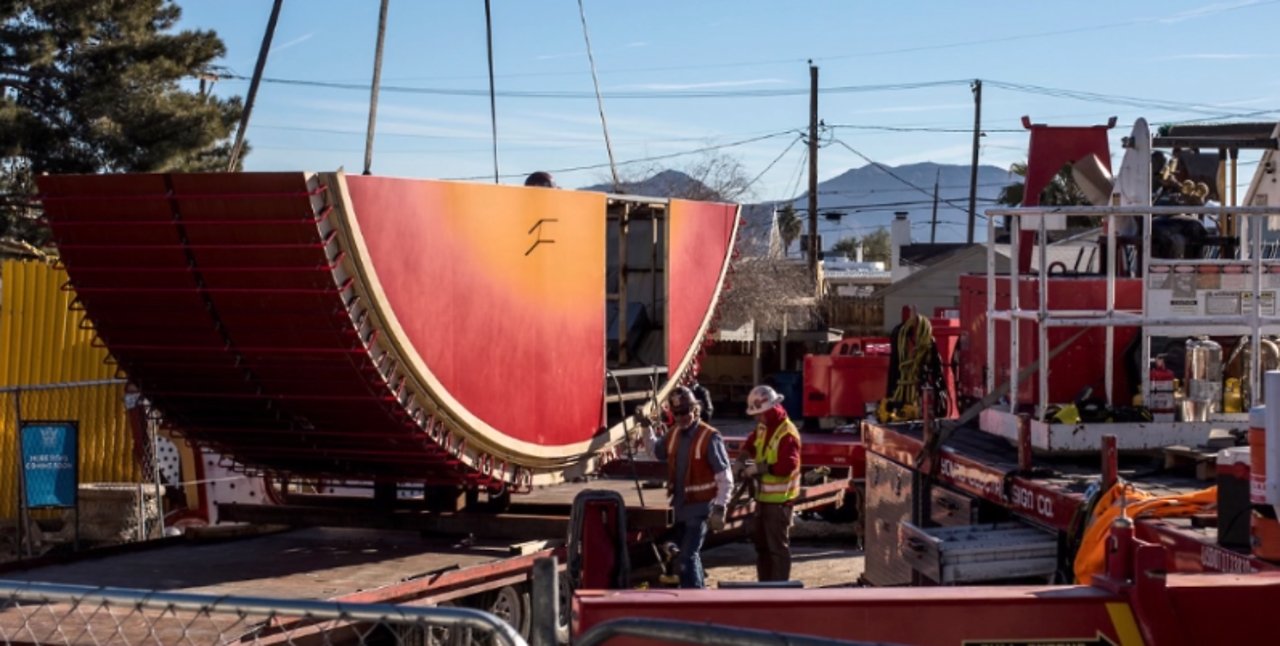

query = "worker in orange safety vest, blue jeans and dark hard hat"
(649, 386), (733, 587)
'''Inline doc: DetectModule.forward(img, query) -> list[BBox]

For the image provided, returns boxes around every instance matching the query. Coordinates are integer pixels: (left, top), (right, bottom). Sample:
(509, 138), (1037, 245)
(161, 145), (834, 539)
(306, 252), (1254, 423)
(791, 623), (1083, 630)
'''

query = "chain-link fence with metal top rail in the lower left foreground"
(0, 581), (526, 646)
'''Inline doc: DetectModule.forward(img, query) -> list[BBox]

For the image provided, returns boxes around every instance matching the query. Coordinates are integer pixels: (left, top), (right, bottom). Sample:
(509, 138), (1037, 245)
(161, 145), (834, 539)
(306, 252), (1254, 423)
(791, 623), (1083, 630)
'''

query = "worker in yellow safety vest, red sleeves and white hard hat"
(736, 385), (800, 581)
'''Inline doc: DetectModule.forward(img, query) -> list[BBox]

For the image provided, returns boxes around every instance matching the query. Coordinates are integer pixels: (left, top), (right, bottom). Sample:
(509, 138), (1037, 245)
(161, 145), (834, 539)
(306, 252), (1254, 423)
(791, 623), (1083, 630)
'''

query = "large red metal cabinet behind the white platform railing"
(960, 275), (1142, 403)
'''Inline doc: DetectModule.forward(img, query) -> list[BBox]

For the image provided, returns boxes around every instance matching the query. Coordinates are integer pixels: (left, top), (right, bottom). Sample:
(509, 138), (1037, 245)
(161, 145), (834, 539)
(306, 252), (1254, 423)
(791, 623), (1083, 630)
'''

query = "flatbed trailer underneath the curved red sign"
(0, 477), (849, 634)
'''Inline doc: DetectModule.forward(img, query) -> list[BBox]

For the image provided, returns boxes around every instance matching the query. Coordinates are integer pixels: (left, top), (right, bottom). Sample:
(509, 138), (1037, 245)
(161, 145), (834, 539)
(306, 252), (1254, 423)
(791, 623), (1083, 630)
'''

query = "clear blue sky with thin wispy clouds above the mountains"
(178, 0), (1280, 200)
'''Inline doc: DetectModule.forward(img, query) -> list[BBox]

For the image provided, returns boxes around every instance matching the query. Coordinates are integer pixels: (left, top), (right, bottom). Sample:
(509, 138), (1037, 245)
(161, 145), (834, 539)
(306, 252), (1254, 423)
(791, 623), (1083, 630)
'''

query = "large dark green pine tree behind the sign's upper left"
(0, 0), (241, 244)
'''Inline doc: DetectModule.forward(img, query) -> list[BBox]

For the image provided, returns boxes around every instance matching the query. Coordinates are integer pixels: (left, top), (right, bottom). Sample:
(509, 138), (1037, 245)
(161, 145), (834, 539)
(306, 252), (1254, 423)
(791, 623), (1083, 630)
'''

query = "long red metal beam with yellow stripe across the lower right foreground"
(571, 530), (1280, 646)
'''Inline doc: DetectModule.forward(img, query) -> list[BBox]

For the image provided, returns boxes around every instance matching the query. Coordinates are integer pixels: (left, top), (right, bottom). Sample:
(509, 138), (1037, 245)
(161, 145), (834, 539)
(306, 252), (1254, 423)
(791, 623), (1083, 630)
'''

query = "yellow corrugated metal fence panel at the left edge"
(0, 260), (140, 518)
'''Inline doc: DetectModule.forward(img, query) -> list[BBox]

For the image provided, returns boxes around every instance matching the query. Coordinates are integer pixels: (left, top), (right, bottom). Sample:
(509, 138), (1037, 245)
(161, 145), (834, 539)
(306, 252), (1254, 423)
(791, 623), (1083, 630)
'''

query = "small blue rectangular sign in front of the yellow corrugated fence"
(22, 422), (79, 509)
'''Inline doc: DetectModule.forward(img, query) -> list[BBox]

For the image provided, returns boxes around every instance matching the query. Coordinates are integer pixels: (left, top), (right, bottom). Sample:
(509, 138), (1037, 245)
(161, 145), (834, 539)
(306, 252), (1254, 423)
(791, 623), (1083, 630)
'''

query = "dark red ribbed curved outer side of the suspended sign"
(40, 173), (483, 486)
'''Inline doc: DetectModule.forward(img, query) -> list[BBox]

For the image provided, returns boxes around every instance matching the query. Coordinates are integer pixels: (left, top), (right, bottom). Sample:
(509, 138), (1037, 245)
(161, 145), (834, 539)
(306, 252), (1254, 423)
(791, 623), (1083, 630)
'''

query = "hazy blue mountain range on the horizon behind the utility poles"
(582, 161), (1021, 253)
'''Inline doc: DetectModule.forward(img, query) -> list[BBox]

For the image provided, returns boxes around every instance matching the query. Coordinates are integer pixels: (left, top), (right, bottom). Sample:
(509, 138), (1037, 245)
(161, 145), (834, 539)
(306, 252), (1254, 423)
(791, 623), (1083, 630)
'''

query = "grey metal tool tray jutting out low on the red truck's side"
(899, 522), (1057, 583)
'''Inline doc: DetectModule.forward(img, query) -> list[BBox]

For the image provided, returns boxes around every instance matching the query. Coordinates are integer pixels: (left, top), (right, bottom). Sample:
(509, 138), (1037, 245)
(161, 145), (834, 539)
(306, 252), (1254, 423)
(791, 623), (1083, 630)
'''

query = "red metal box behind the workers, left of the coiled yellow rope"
(804, 336), (890, 418)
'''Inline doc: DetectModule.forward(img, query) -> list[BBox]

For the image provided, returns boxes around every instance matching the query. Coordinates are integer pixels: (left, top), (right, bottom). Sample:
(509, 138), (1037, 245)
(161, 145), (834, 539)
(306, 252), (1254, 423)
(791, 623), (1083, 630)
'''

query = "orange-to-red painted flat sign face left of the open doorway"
(347, 177), (605, 446)
